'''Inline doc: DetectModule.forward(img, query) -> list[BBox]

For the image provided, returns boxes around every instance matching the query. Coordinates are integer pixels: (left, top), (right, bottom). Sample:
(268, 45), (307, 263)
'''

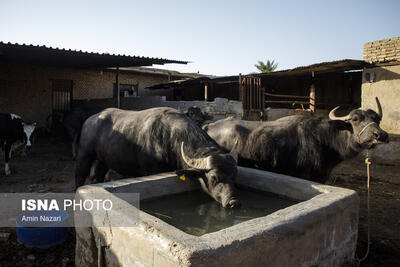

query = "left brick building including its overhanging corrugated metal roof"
(0, 42), (193, 127)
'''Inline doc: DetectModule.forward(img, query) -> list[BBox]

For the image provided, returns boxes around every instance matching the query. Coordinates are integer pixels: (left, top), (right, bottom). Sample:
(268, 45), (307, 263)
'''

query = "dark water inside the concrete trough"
(140, 189), (298, 236)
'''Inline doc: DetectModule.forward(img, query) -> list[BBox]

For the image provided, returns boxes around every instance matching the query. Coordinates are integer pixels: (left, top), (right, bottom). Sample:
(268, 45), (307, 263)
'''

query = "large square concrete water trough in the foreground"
(75, 167), (359, 267)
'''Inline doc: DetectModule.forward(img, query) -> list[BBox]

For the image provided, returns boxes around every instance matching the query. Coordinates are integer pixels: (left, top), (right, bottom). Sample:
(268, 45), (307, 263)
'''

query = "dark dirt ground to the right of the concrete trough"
(332, 158), (400, 267)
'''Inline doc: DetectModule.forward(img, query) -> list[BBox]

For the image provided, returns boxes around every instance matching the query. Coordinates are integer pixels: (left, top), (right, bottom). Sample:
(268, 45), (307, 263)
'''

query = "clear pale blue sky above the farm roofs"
(0, 0), (400, 75)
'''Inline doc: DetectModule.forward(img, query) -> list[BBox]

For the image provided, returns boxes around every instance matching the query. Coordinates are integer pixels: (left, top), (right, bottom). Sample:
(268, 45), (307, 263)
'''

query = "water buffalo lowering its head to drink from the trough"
(75, 108), (239, 207)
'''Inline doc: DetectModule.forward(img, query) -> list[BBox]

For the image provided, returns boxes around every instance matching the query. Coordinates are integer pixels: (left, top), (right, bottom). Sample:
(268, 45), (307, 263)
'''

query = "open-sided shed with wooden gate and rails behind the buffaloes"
(148, 59), (372, 119)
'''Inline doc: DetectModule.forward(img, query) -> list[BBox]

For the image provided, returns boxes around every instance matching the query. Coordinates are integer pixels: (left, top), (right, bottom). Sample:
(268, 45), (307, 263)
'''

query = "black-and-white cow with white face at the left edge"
(0, 113), (36, 175)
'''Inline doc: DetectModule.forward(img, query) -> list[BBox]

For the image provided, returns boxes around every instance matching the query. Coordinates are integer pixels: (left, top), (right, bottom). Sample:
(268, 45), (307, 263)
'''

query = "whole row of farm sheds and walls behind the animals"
(0, 38), (400, 134)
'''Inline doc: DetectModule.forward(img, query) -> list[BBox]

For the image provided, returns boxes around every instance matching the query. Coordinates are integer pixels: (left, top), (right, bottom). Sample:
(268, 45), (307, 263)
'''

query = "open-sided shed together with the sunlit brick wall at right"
(148, 37), (400, 135)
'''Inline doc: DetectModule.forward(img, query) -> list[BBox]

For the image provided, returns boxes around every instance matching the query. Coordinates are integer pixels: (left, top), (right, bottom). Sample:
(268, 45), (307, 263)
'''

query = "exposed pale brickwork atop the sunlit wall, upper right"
(363, 37), (400, 63)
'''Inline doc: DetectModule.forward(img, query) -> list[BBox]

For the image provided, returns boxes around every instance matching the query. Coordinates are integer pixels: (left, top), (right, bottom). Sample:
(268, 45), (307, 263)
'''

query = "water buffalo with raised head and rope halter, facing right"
(203, 99), (389, 183)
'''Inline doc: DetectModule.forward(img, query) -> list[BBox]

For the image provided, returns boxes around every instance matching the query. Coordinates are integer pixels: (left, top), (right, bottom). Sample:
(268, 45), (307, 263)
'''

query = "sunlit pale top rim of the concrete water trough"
(76, 167), (359, 254)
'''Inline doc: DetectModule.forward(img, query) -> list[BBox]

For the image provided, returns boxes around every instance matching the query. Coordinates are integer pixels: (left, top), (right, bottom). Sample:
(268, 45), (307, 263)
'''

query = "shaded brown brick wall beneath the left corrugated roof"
(0, 64), (173, 127)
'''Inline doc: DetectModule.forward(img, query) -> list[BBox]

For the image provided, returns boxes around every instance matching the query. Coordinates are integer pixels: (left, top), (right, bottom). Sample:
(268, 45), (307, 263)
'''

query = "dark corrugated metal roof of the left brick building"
(0, 42), (188, 68)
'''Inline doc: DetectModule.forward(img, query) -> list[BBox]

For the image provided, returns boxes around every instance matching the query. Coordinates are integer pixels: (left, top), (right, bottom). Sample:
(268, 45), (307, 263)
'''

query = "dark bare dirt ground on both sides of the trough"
(0, 137), (400, 266)
